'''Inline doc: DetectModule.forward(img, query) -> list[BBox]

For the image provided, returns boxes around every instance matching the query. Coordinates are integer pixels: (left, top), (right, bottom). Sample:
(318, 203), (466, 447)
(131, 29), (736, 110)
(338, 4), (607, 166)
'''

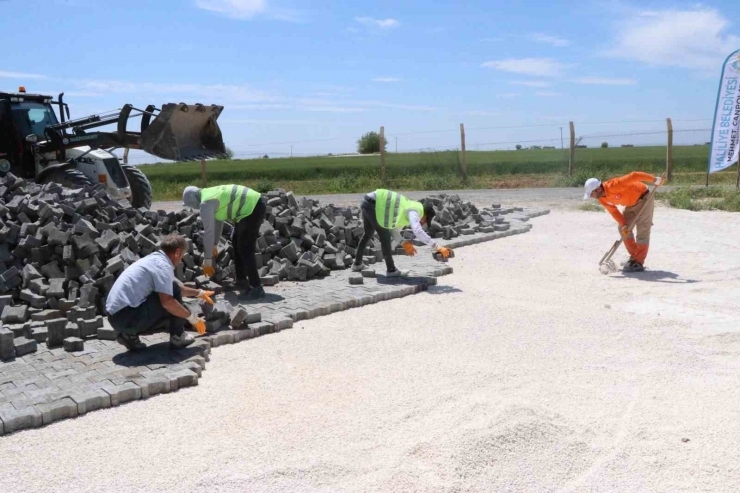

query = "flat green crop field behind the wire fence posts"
(140, 146), (736, 200)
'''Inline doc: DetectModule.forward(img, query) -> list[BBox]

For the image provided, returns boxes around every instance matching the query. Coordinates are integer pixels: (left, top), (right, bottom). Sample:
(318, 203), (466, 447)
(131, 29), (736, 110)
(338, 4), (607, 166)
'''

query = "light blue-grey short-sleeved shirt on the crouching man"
(105, 251), (175, 315)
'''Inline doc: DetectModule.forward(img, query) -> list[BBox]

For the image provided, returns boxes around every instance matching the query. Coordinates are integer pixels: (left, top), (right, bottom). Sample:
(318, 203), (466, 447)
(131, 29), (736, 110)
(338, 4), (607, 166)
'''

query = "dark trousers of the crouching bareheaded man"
(108, 282), (187, 336)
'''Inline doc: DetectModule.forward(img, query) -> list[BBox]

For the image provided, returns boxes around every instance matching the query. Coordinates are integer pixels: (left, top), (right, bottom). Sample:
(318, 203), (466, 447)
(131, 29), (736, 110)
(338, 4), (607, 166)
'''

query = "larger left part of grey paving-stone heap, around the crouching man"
(0, 173), (234, 359)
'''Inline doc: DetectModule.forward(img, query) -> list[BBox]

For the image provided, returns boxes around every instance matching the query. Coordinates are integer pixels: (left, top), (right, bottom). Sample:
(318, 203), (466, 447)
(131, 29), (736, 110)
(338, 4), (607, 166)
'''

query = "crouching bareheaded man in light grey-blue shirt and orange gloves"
(105, 234), (213, 351)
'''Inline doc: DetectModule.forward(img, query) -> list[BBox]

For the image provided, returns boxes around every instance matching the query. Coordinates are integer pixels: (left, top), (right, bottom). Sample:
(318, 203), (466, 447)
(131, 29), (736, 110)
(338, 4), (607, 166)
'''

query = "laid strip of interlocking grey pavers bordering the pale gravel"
(0, 211), (548, 435)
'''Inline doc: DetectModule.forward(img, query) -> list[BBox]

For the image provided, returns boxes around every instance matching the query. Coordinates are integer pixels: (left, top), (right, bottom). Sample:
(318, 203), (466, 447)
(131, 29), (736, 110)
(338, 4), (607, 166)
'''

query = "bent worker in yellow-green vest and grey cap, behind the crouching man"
(182, 185), (267, 299)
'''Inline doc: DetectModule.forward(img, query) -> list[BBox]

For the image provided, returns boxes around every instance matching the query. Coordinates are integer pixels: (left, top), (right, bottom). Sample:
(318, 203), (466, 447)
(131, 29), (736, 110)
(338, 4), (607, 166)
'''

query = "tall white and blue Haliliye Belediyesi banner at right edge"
(709, 50), (740, 173)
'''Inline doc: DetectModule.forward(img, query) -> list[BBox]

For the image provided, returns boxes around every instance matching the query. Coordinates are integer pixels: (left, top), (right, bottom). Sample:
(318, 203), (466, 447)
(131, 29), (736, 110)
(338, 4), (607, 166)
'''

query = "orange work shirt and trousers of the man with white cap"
(599, 171), (655, 264)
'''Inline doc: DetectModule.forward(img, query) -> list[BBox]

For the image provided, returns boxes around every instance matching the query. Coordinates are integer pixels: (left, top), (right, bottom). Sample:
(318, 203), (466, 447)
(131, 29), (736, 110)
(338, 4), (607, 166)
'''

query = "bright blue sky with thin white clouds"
(0, 0), (740, 160)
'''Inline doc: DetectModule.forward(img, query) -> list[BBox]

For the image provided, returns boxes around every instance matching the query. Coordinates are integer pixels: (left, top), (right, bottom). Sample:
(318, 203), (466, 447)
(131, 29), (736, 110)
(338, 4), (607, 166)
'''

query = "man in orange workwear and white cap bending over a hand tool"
(583, 171), (664, 272)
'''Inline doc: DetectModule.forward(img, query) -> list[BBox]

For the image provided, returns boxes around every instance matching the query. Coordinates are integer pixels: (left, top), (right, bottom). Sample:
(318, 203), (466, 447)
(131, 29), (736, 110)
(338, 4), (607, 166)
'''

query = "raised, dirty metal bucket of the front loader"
(139, 103), (226, 161)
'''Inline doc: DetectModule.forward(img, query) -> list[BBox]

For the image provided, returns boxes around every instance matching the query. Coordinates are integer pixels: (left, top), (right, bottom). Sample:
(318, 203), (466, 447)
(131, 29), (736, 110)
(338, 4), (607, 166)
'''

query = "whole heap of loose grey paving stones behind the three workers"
(0, 173), (512, 359)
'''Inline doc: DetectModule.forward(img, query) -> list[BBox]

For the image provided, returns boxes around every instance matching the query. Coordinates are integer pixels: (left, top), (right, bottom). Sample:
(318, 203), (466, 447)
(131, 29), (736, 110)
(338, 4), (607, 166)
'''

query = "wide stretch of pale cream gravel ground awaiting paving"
(0, 202), (740, 493)
